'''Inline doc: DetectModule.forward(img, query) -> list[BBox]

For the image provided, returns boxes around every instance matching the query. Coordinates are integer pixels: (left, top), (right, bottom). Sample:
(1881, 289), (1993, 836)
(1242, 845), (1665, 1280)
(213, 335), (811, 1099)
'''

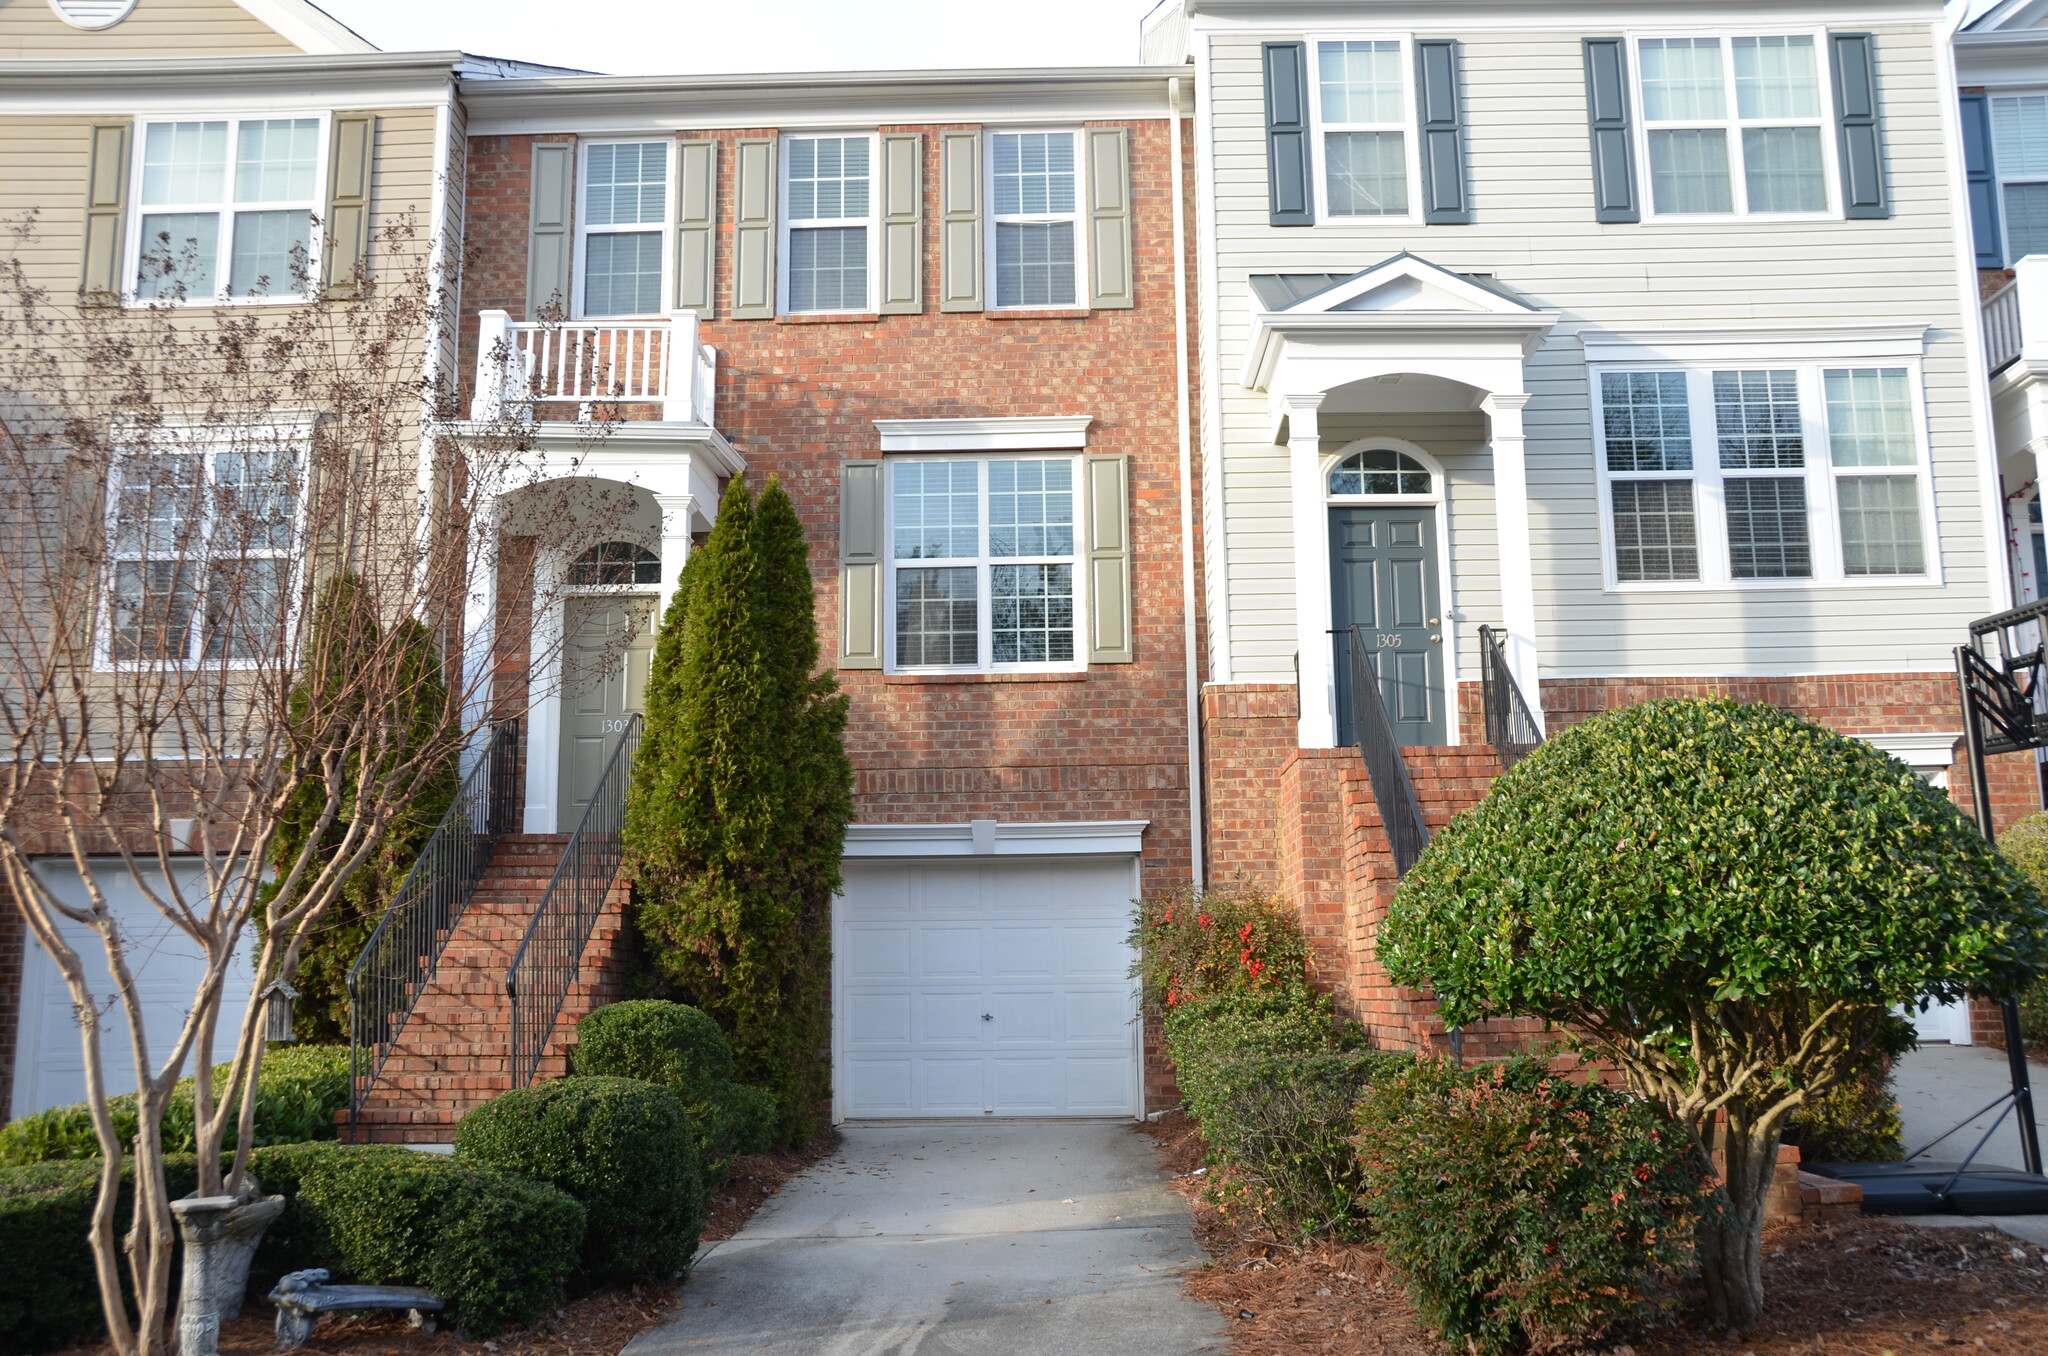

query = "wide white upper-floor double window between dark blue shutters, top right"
(1636, 33), (1833, 217)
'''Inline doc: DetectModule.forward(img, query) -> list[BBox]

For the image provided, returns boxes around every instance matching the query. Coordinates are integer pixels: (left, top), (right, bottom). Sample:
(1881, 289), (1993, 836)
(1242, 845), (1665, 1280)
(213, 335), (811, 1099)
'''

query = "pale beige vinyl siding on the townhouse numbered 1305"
(1196, 25), (1989, 682)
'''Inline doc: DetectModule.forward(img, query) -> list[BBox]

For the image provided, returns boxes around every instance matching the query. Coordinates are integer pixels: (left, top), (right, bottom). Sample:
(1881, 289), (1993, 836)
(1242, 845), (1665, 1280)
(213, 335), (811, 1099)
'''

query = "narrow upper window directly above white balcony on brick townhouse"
(578, 141), (668, 317)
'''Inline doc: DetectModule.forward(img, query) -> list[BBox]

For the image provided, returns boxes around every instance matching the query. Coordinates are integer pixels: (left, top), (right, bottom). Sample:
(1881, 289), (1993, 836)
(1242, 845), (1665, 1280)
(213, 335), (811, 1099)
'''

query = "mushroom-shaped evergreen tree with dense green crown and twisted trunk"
(1380, 701), (2048, 1327)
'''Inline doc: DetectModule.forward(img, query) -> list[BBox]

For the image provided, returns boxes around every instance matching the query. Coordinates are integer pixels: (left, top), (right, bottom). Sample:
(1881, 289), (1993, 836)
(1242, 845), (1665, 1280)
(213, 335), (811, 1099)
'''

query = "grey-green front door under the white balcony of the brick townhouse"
(555, 598), (653, 834)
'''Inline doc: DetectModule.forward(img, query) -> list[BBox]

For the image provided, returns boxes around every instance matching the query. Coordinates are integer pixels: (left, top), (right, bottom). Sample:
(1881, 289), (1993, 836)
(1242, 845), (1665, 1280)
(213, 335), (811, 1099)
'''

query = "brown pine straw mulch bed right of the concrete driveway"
(1143, 1112), (2048, 1356)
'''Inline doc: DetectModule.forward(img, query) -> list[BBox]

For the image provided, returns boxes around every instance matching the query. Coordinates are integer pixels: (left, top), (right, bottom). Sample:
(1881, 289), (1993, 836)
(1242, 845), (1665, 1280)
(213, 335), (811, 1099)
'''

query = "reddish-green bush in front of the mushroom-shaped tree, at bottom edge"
(1358, 1057), (1708, 1354)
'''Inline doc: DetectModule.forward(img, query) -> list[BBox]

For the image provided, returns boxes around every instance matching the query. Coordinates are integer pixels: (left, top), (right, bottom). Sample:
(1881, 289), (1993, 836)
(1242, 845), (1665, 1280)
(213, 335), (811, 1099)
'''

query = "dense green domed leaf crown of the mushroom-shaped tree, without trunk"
(1380, 701), (2048, 1030)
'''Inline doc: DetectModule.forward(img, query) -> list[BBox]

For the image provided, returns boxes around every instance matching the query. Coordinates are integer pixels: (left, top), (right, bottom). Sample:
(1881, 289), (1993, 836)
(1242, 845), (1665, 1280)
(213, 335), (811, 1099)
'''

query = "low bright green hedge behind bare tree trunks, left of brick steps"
(0, 1045), (348, 1163)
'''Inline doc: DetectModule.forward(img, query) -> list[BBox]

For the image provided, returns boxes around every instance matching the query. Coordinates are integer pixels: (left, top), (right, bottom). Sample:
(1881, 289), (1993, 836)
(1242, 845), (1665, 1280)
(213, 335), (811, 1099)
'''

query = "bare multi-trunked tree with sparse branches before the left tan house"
(0, 219), (622, 1356)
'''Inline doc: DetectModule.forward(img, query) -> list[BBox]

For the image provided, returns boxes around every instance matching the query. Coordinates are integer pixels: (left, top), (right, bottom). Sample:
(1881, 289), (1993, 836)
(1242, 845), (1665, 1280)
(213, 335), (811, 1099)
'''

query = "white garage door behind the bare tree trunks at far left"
(14, 858), (252, 1116)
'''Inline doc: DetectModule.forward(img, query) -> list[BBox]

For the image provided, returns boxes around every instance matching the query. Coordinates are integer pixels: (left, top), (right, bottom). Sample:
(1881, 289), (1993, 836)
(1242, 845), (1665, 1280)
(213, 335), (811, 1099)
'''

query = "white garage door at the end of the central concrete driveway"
(834, 858), (1139, 1120)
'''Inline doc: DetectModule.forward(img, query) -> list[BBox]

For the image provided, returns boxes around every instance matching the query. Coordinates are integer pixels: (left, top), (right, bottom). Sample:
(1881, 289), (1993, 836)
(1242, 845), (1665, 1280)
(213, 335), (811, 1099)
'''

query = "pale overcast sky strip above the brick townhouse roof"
(317, 0), (1153, 76)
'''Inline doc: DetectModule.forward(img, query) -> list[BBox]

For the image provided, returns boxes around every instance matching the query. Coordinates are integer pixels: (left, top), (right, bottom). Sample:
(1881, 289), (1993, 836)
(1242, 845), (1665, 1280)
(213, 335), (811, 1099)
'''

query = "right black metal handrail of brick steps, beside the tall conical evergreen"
(506, 715), (641, 1088)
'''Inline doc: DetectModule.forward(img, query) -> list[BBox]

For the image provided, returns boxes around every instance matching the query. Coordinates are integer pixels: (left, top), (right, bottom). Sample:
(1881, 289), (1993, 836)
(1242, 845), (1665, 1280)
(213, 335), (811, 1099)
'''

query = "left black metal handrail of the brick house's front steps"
(348, 719), (518, 1131)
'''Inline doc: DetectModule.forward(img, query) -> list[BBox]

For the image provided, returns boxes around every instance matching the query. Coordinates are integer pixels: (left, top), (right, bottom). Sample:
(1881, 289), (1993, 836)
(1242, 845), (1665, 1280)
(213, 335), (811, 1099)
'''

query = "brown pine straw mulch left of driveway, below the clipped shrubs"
(57, 1129), (840, 1356)
